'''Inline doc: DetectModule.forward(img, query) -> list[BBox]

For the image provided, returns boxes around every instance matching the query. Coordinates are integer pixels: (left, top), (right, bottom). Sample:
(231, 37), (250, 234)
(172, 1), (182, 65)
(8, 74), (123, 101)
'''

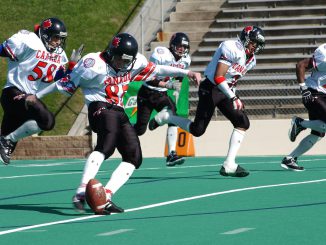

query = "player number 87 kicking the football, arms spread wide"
(21, 33), (201, 214)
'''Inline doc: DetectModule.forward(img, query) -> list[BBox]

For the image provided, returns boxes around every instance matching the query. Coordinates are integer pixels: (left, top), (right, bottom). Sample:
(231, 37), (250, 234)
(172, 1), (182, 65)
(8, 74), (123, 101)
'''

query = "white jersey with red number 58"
(3, 30), (68, 94)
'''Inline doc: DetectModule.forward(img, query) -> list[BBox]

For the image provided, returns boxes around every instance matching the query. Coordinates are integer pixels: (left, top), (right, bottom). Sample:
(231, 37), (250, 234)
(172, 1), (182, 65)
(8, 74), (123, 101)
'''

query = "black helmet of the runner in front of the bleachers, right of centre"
(240, 26), (265, 54)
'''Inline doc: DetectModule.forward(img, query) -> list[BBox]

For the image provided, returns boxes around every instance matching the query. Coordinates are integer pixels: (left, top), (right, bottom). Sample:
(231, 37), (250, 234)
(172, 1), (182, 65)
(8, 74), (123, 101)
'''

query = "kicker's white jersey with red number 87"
(56, 52), (181, 107)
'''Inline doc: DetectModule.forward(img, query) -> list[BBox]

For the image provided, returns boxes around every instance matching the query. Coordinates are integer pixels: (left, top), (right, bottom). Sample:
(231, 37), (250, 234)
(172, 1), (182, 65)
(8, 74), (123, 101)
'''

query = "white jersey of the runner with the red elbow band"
(205, 40), (256, 89)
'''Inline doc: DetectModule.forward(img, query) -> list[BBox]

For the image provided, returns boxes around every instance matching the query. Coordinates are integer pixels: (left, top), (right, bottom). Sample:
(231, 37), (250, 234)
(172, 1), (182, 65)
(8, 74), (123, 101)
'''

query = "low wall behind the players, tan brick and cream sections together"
(13, 119), (326, 159)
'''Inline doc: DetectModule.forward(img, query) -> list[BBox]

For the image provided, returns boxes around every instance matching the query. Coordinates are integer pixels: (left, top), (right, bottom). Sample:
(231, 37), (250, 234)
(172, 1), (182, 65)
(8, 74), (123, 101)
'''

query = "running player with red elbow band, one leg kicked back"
(150, 26), (265, 177)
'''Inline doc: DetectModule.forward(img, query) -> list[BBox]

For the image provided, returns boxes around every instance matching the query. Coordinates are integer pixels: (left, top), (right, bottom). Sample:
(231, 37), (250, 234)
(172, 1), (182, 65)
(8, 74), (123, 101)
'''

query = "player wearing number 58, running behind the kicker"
(0, 18), (82, 164)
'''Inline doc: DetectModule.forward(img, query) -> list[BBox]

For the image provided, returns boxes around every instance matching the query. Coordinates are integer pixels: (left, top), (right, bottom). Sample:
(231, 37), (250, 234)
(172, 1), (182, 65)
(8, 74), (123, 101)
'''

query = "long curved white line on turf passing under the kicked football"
(0, 179), (326, 235)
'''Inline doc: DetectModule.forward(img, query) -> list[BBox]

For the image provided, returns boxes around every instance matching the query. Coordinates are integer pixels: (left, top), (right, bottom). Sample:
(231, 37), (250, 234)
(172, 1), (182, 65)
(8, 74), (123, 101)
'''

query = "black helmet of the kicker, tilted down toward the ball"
(104, 33), (138, 72)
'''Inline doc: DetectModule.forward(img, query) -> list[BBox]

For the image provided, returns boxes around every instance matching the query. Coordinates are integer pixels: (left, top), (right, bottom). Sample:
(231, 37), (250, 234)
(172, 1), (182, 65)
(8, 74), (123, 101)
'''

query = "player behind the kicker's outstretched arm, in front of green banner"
(134, 32), (191, 166)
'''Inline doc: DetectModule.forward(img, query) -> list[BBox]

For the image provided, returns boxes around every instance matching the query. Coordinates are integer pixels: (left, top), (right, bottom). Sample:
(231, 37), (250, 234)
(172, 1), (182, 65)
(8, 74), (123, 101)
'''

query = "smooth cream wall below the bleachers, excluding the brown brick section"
(113, 119), (326, 157)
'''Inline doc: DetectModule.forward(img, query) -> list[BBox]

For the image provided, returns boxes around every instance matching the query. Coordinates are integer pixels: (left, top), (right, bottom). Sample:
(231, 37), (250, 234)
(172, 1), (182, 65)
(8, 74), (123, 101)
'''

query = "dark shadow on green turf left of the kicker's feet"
(0, 203), (86, 217)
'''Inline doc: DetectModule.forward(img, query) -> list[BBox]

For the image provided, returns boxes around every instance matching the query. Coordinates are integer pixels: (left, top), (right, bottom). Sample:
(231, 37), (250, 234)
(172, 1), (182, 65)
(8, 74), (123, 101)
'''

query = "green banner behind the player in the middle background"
(123, 77), (189, 124)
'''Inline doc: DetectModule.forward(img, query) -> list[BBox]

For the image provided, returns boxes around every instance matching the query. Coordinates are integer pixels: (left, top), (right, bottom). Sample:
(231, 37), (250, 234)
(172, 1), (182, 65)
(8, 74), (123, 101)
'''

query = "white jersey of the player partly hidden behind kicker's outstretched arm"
(144, 47), (191, 92)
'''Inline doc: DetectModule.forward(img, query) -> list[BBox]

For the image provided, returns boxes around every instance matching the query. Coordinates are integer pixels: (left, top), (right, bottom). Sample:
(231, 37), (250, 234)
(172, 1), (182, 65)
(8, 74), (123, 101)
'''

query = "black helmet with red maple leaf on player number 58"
(38, 18), (68, 53)
